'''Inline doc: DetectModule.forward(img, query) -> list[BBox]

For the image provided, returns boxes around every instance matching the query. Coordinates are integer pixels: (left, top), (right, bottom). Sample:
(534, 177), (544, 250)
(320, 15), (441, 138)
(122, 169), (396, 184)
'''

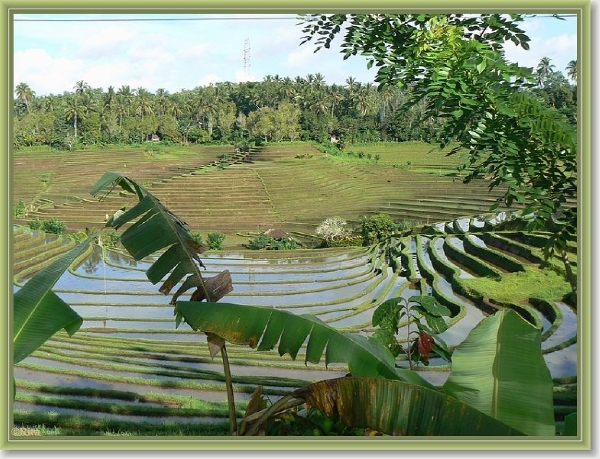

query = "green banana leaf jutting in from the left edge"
(13, 235), (94, 363)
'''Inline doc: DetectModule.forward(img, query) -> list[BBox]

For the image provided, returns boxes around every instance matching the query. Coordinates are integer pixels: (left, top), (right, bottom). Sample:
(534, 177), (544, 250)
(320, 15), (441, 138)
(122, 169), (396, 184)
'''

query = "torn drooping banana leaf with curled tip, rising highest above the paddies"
(91, 172), (233, 304)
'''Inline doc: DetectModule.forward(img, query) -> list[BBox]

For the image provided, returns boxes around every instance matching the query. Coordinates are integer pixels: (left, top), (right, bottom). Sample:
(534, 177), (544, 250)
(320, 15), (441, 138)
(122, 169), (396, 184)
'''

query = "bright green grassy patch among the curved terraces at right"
(460, 266), (571, 304)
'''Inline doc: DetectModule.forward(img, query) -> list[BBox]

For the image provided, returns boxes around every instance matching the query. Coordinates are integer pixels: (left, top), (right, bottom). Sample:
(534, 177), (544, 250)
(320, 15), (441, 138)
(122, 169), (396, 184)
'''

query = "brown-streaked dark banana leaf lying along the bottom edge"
(293, 377), (523, 436)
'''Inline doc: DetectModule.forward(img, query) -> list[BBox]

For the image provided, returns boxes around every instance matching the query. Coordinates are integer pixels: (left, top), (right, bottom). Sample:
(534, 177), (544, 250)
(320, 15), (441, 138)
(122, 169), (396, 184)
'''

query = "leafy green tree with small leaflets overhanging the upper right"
(302, 14), (577, 293)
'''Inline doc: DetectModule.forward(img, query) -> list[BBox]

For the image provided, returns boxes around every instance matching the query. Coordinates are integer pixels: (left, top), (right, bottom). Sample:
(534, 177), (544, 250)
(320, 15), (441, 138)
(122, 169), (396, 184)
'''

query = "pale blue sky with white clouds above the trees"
(14, 14), (577, 96)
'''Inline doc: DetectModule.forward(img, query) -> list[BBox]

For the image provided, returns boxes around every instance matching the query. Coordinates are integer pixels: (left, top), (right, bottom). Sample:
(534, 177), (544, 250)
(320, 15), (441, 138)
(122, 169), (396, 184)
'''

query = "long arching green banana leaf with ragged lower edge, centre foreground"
(176, 301), (434, 389)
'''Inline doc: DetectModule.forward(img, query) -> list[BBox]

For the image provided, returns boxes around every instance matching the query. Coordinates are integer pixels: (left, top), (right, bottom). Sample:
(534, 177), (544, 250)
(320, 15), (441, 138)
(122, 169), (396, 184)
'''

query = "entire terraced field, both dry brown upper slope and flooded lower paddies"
(13, 146), (578, 435)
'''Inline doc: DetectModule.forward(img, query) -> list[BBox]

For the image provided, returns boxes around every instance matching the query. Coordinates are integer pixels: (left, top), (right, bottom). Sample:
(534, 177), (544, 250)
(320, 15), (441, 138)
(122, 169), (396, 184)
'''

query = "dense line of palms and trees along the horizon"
(13, 57), (577, 149)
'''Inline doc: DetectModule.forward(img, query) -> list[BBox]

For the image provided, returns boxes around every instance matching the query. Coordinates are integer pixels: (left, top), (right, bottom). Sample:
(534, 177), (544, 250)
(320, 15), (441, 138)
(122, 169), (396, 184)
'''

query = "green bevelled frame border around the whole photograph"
(0, 0), (597, 450)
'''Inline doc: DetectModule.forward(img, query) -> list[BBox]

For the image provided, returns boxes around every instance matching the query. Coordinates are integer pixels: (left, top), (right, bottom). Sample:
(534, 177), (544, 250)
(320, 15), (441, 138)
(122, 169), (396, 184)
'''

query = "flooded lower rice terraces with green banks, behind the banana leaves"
(15, 219), (577, 435)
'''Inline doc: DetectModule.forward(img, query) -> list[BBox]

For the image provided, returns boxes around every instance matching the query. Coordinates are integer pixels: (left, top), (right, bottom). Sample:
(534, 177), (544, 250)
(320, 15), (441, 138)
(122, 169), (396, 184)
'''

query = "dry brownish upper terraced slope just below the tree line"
(13, 145), (512, 243)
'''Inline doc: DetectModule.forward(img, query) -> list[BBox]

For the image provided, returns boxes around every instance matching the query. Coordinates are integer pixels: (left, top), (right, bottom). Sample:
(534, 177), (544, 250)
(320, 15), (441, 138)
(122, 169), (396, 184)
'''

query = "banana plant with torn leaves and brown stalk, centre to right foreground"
(92, 172), (554, 435)
